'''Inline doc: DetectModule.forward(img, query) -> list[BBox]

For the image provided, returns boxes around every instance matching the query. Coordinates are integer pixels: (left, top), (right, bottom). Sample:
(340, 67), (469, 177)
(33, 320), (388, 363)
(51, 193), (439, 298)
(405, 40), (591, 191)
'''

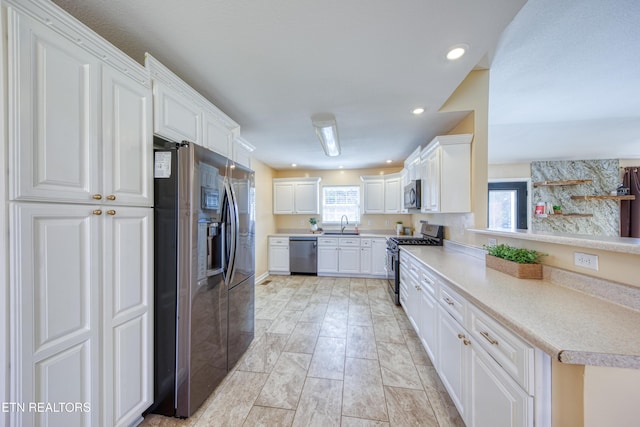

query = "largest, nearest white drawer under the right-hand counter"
(468, 307), (534, 395)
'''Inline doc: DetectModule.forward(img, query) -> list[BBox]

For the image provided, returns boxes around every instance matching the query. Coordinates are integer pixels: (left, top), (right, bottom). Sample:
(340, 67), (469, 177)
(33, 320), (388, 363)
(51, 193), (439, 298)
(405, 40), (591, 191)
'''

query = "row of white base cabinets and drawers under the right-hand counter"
(400, 250), (550, 427)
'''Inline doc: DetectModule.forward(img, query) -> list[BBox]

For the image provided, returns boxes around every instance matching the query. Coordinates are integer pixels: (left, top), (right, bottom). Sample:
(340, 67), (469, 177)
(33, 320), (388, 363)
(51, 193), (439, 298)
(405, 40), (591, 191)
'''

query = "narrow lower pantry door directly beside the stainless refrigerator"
(103, 207), (153, 425)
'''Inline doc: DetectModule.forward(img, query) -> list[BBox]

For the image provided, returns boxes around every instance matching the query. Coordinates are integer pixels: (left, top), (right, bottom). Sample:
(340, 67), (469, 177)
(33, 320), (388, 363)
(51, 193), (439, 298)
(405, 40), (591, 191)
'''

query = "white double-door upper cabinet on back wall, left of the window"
(273, 178), (320, 215)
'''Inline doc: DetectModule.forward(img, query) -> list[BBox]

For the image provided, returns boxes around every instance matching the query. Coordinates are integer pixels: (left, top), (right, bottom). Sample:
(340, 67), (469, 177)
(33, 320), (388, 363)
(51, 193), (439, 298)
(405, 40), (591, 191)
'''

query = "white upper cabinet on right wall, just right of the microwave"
(421, 134), (473, 213)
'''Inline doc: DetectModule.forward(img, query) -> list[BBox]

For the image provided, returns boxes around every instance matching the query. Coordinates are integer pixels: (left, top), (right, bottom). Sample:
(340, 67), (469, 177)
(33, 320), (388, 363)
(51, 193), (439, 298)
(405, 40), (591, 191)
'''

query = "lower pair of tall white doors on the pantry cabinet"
(10, 203), (153, 426)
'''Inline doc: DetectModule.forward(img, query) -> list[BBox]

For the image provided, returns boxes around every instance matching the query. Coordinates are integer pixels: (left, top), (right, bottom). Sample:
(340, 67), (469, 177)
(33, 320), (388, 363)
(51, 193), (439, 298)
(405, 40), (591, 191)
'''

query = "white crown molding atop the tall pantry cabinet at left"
(3, 0), (151, 87)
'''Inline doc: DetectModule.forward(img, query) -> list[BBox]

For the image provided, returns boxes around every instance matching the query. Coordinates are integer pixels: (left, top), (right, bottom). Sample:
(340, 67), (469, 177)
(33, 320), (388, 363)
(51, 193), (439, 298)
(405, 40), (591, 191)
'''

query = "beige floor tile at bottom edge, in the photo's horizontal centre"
(293, 377), (342, 427)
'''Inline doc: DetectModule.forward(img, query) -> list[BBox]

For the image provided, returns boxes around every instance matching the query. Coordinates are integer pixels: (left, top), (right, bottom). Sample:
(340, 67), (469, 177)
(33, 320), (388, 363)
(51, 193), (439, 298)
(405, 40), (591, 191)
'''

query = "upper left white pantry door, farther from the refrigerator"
(9, 12), (101, 203)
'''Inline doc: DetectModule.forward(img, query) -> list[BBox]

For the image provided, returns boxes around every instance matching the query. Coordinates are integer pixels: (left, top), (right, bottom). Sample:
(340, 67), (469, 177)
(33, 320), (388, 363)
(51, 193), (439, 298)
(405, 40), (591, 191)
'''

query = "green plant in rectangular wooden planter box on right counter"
(484, 244), (547, 279)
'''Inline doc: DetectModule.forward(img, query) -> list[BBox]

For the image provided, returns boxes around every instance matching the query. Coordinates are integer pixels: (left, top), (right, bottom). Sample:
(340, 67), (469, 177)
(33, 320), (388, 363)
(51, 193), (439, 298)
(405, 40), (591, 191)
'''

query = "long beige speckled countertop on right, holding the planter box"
(401, 246), (640, 369)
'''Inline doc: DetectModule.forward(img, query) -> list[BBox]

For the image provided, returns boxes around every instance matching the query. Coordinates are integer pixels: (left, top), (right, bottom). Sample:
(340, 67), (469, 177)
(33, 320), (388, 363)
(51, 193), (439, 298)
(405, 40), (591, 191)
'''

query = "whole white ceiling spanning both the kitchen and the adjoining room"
(54, 0), (640, 169)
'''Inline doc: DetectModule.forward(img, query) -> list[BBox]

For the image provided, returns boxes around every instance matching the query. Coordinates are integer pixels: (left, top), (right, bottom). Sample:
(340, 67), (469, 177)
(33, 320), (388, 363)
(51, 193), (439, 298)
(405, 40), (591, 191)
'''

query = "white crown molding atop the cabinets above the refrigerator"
(144, 52), (240, 134)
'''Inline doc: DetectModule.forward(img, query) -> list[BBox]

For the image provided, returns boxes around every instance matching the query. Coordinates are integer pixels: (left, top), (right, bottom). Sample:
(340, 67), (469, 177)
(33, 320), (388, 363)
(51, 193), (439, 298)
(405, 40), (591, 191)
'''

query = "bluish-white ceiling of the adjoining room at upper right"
(489, 0), (640, 163)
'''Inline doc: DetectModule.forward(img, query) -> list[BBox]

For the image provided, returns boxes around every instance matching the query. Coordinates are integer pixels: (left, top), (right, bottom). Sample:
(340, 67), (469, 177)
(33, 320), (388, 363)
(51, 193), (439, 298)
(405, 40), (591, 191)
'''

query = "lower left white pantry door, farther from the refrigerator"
(10, 203), (102, 426)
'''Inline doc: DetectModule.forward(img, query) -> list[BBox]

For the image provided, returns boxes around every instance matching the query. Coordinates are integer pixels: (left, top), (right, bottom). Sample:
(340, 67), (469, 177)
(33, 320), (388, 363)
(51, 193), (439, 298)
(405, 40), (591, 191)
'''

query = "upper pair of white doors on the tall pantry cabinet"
(8, 5), (153, 206)
